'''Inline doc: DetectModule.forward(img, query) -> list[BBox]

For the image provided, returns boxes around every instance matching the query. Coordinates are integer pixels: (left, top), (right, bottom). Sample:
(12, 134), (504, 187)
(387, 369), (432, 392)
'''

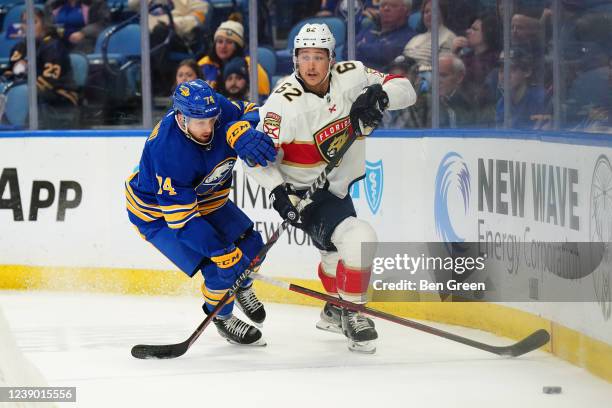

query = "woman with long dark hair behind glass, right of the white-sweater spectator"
(453, 14), (501, 126)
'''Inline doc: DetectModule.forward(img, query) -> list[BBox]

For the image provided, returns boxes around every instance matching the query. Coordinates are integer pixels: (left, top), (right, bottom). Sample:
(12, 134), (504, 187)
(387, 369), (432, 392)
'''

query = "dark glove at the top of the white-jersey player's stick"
(350, 84), (389, 133)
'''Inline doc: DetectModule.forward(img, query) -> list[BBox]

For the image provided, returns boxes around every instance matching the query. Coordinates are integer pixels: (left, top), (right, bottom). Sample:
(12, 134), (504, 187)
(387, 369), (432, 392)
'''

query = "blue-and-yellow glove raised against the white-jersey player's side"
(227, 120), (276, 167)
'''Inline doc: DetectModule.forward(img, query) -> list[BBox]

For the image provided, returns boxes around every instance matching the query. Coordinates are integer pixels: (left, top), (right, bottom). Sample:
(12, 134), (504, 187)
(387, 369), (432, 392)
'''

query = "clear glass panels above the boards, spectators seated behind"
(0, 0), (612, 133)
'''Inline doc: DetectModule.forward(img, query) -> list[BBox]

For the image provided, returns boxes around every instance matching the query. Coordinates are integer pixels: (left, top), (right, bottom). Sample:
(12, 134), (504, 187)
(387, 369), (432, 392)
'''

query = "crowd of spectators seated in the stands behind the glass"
(0, 0), (612, 132)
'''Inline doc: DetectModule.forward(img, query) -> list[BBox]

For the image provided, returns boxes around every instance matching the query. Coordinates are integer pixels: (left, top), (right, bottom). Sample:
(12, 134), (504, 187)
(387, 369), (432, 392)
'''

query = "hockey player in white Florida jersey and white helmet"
(247, 24), (416, 353)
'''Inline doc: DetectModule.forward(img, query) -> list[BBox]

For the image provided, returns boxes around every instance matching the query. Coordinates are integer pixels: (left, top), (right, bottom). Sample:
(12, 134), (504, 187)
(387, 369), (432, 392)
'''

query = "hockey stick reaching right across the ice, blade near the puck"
(254, 274), (550, 357)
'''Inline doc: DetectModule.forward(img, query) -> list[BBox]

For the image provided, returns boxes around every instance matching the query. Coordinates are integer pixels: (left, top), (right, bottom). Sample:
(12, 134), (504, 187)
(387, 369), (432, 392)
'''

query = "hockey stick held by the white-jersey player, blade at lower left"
(132, 122), (374, 359)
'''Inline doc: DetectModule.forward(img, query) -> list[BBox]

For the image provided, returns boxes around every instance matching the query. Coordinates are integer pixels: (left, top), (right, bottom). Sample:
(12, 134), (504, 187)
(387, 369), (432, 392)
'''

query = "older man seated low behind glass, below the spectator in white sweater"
(438, 52), (477, 128)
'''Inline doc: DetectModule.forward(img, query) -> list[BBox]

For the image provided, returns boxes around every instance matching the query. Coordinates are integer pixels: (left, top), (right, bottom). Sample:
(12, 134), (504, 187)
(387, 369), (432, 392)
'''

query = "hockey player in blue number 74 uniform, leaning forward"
(125, 79), (276, 345)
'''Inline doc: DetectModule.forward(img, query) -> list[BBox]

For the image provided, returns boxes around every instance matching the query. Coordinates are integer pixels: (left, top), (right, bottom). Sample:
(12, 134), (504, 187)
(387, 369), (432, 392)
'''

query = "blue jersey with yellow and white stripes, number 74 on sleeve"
(125, 94), (259, 255)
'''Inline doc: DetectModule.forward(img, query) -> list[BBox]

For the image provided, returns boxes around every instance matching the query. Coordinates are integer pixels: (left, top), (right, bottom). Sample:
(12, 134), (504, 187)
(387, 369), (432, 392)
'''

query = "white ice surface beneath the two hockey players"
(0, 291), (612, 408)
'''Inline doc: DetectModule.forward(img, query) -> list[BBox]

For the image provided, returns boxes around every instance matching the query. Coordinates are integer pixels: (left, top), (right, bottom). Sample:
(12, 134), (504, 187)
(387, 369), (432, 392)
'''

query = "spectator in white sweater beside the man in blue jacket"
(403, 0), (456, 71)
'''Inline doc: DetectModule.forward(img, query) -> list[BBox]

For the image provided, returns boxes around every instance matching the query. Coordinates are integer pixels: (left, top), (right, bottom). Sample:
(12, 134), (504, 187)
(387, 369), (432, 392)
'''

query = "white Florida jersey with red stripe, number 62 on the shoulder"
(247, 61), (416, 197)
